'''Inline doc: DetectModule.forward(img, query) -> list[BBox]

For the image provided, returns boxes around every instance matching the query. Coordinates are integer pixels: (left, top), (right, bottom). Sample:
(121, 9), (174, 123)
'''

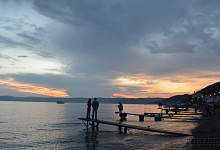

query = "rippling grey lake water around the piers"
(0, 101), (196, 150)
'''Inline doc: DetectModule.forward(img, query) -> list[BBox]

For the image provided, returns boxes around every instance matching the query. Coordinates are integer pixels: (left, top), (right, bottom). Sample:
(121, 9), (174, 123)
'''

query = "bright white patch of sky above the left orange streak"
(0, 49), (64, 74)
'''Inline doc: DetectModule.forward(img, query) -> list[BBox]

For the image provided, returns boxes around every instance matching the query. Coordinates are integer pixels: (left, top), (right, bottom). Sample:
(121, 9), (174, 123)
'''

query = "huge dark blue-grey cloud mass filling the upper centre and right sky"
(31, 0), (220, 75)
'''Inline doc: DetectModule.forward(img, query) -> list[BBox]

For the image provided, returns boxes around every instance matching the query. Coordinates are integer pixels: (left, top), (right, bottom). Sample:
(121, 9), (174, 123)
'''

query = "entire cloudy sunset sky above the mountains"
(0, 0), (220, 98)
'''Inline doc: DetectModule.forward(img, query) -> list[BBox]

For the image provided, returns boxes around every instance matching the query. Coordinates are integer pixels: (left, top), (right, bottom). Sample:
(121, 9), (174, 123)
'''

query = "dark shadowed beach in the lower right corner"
(189, 109), (220, 150)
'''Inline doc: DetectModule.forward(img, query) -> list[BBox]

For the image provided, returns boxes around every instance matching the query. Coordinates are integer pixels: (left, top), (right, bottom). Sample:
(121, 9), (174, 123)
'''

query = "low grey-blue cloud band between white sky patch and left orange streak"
(8, 74), (117, 97)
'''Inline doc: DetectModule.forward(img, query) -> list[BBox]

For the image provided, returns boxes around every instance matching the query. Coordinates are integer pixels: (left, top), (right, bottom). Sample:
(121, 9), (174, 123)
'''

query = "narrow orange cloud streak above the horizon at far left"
(0, 78), (69, 97)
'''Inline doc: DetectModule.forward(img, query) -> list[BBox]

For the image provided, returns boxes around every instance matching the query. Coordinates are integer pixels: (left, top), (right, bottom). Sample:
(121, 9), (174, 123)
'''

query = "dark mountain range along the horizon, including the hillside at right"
(0, 82), (220, 104)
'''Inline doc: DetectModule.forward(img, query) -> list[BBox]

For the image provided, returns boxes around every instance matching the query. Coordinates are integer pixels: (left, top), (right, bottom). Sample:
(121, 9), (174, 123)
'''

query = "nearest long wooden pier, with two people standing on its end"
(78, 118), (191, 136)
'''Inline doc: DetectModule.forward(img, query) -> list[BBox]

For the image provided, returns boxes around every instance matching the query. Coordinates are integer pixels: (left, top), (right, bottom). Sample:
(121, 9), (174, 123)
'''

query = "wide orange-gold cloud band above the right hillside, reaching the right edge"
(113, 74), (219, 98)
